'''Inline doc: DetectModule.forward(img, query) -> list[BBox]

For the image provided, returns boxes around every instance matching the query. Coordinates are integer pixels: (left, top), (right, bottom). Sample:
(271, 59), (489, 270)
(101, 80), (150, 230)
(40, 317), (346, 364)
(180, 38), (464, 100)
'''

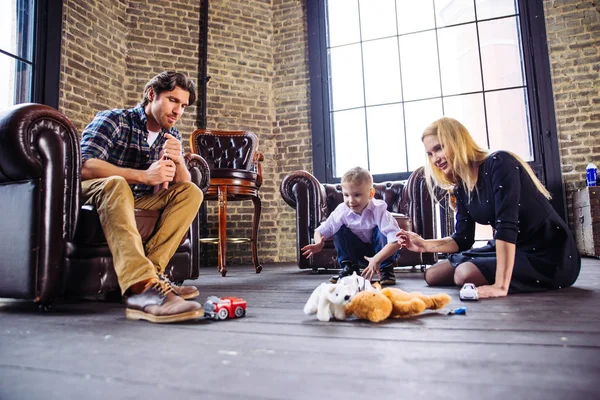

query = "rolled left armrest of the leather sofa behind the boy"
(279, 171), (328, 268)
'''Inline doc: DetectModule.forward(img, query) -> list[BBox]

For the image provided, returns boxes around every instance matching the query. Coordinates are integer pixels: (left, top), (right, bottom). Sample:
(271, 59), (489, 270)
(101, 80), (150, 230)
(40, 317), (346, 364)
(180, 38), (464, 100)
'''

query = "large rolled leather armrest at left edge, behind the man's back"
(0, 103), (81, 302)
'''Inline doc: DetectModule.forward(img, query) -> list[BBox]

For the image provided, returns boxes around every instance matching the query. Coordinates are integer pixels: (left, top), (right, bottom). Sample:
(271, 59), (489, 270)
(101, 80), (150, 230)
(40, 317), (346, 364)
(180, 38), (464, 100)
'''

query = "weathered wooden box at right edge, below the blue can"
(573, 186), (600, 257)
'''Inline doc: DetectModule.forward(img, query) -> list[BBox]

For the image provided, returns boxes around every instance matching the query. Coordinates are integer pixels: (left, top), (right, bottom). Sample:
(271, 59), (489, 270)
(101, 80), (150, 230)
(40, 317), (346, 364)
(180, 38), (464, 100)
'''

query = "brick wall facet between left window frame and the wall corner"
(59, 0), (127, 132)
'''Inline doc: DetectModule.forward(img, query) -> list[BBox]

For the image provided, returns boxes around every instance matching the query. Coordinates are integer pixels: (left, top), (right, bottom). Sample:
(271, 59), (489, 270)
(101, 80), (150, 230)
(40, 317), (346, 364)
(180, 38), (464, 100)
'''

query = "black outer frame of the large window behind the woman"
(307, 0), (566, 219)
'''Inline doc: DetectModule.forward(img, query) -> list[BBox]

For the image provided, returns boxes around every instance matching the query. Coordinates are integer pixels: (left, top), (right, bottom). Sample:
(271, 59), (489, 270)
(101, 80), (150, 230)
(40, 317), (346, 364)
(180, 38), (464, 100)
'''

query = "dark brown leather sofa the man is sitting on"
(0, 104), (210, 305)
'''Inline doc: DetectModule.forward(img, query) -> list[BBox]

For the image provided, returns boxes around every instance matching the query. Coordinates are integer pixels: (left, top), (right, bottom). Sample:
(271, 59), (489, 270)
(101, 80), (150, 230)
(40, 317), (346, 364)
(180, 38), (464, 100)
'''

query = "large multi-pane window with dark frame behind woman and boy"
(307, 0), (564, 219)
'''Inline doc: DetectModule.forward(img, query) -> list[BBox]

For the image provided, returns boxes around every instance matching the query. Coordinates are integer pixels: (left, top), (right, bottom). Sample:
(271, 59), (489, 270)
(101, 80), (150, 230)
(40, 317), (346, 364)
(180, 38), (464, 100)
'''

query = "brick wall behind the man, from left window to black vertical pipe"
(59, 0), (200, 141)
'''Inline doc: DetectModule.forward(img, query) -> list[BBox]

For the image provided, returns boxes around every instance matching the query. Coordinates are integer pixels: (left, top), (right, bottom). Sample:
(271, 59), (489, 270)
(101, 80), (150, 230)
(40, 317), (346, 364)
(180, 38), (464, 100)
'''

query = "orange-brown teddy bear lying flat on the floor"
(345, 288), (451, 322)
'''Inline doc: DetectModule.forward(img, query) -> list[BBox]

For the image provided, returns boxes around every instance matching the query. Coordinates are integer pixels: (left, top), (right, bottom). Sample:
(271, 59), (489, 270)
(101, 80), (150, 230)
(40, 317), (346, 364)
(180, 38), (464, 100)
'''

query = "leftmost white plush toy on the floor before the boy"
(304, 283), (351, 322)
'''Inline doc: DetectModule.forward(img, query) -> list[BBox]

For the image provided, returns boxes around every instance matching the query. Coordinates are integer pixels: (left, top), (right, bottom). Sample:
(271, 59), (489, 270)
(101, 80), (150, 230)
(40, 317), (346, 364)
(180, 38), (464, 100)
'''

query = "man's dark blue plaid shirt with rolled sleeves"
(81, 105), (183, 198)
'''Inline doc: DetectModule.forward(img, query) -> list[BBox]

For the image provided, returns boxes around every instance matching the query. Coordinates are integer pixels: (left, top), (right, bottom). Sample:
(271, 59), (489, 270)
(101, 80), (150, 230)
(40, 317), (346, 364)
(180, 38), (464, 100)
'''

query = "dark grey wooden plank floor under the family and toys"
(0, 258), (600, 400)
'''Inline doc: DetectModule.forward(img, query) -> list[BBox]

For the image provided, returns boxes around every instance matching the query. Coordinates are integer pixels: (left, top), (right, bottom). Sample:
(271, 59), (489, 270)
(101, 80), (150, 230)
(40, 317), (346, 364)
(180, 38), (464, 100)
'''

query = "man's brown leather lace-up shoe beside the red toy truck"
(125, 280), (204, 323)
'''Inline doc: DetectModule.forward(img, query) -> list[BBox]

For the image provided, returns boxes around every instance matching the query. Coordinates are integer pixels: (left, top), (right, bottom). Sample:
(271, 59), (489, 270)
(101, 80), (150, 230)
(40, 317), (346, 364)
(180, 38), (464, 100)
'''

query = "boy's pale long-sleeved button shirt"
(316, 199), (400, 243)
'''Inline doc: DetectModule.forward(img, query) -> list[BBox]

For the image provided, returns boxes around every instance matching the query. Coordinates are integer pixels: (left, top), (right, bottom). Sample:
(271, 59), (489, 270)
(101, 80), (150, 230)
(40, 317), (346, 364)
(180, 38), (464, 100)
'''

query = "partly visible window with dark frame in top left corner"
(0, 0), (62, 110)
